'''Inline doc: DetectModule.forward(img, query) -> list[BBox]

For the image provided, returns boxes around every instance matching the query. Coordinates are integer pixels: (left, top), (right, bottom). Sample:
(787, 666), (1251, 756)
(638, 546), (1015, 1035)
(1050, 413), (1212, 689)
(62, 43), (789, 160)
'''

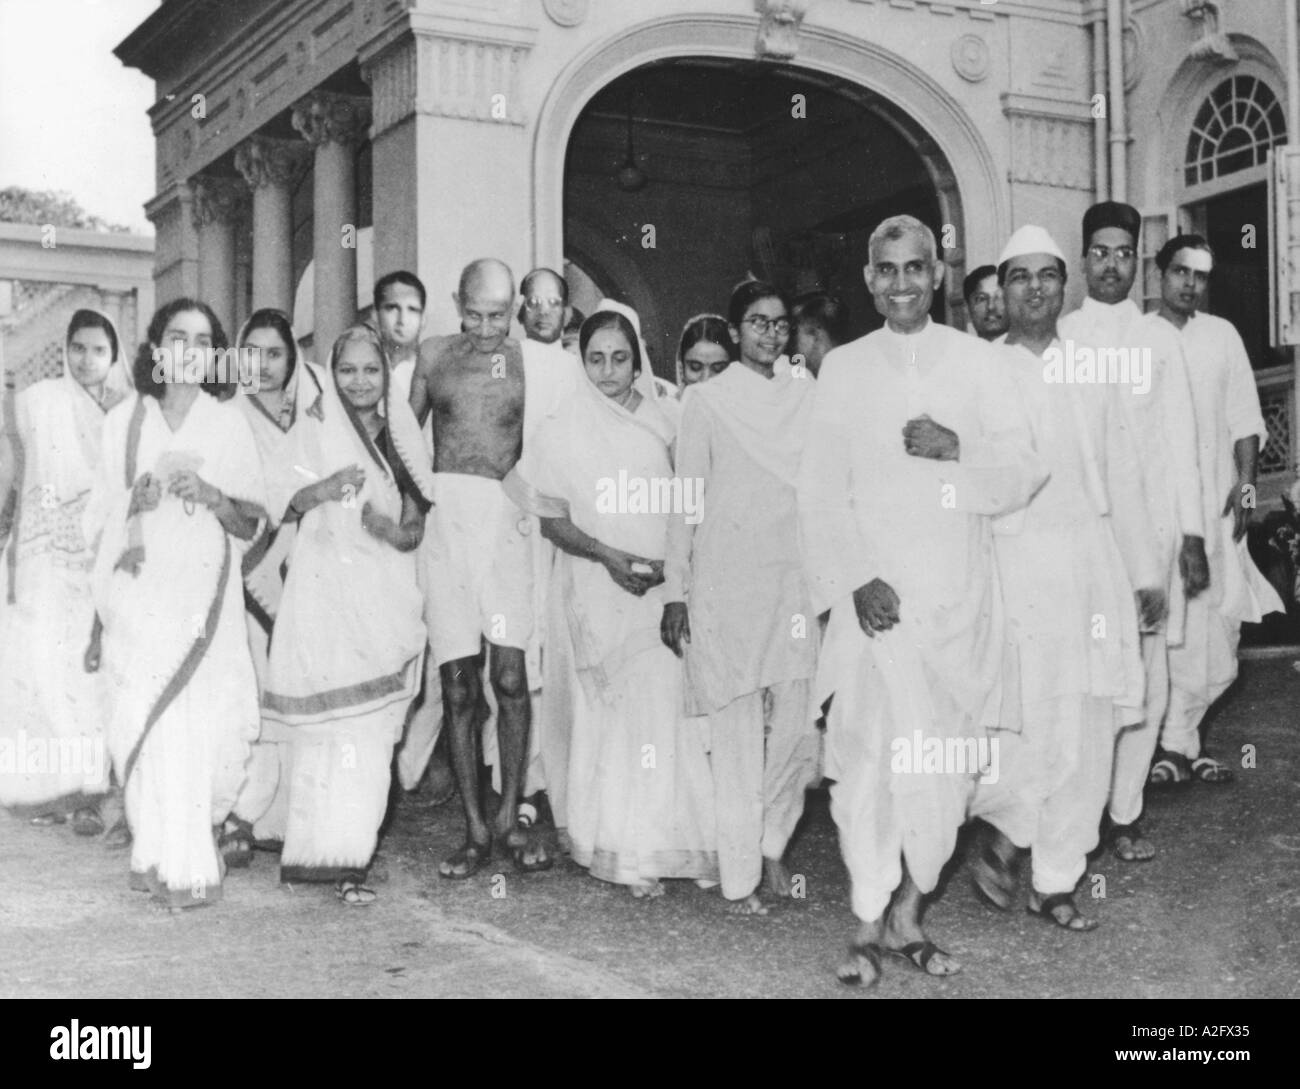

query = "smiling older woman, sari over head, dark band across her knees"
(263, 326), (432, 906)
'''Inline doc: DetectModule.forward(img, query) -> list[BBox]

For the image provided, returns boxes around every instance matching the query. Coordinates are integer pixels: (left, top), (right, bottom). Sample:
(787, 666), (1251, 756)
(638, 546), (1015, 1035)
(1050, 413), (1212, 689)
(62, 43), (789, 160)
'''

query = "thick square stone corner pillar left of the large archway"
(358, 10), (537, 334)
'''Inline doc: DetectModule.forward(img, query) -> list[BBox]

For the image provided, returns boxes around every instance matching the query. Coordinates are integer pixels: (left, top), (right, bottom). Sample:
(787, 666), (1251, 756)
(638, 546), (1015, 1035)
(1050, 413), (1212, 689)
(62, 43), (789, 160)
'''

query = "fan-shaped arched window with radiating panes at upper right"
(1183, 75), (1287, 186)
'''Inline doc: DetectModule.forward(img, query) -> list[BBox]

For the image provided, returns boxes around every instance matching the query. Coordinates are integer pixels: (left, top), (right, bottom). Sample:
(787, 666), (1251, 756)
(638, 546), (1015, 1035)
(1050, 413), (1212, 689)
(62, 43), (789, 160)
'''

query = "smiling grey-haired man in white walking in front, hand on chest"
(798, 216), (1047, 985)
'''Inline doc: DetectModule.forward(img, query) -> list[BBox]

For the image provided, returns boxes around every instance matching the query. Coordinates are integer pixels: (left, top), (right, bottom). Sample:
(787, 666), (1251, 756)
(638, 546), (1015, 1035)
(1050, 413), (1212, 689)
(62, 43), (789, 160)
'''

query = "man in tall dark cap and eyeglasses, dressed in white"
(1060, 200), (1209, 862)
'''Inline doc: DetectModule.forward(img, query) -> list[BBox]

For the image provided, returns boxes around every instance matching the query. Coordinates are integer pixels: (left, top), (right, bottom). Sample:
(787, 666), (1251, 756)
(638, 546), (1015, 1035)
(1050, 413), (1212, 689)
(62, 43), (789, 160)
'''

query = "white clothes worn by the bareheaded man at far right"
(1161, 313), (1284, 758)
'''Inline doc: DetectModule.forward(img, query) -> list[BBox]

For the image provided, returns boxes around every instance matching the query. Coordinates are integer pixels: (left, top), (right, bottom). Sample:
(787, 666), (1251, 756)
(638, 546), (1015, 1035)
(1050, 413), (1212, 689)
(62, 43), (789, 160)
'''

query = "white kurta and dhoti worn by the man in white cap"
(971, 342), (1157, 895)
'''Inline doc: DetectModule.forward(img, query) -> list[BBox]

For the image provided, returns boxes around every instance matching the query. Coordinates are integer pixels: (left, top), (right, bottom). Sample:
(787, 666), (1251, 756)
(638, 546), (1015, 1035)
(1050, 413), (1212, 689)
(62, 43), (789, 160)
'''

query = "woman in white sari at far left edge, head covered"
(0, 309), (130, 836)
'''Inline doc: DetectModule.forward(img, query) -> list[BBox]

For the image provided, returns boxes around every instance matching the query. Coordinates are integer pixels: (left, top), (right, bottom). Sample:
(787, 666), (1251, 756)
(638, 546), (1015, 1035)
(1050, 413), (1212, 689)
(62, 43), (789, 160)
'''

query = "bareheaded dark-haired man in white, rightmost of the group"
(1149, 234), (1284, 784)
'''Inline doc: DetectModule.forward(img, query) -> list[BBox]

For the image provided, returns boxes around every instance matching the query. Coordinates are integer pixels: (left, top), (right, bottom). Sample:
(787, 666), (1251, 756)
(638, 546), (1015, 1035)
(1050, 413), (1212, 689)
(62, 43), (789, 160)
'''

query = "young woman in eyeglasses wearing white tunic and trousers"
(660, 281), (818, 915)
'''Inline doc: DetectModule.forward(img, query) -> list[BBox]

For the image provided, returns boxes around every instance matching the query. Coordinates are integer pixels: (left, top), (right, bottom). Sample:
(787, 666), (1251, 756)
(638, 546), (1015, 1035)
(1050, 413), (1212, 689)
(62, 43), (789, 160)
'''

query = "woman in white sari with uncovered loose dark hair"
(87, 299), (265, 908)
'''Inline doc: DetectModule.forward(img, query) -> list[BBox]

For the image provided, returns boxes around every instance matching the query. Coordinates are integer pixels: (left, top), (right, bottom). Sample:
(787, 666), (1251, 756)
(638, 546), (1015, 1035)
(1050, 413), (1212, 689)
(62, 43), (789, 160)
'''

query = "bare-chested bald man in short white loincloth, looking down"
(411, 259), (574, 880)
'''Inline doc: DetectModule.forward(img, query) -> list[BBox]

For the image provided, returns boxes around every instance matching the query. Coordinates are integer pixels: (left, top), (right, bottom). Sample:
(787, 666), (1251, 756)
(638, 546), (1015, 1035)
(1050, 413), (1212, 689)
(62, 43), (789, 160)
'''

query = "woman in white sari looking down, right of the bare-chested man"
(504, 312), (718, 897)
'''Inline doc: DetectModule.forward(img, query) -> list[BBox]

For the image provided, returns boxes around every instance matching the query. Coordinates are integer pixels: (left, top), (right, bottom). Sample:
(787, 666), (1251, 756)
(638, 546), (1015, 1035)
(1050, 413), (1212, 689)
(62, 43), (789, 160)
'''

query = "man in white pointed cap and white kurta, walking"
(971, 226), (1165, 930)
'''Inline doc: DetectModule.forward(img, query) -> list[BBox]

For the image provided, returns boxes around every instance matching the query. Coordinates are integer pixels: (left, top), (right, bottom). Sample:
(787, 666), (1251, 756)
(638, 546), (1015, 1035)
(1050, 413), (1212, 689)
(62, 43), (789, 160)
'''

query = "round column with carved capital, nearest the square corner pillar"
(294, 91), (371, 364)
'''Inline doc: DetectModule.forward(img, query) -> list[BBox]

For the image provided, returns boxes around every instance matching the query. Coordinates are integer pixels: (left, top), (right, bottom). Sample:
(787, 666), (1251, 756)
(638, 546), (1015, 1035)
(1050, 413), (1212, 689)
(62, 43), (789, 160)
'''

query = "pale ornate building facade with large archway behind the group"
(117, 0), (1300, 491)
